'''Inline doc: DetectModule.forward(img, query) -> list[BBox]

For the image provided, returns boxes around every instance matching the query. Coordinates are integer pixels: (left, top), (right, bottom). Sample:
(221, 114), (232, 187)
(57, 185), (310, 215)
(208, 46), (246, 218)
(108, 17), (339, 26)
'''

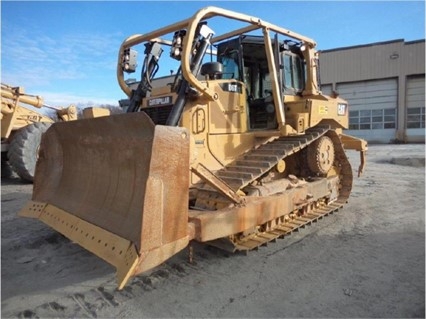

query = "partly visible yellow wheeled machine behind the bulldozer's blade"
(0, 83), (77, 182)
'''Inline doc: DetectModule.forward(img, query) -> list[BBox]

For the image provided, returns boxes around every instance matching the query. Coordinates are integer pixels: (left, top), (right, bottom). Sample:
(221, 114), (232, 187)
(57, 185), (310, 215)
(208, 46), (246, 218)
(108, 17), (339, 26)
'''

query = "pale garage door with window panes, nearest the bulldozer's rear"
(336, 79), (398, 143)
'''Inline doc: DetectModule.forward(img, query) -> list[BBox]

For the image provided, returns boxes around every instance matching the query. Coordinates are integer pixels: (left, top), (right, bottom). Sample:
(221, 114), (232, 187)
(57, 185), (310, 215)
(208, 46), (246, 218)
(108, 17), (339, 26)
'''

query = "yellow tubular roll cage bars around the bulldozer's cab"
(117, 7), (319, 126)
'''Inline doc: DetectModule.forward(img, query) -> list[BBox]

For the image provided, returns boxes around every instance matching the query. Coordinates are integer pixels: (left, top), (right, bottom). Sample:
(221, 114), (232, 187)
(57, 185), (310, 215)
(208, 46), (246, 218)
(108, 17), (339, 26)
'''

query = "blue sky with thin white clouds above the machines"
(0, 0), (425, 107)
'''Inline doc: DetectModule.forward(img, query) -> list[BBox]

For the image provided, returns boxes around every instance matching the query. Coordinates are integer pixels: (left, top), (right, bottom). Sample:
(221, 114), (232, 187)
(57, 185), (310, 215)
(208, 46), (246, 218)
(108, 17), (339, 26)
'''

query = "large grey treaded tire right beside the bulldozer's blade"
(8, 122), (52, 182)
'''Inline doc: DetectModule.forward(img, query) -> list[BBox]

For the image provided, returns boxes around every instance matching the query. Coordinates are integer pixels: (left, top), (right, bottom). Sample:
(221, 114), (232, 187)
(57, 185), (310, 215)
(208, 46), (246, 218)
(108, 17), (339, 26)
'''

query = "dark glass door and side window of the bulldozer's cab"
(217, 35), (306, 130)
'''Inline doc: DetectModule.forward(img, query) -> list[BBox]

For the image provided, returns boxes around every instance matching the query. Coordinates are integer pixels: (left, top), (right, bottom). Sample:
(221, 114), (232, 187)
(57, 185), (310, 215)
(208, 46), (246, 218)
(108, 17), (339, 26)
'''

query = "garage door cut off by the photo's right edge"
(405, 76), (425, 142)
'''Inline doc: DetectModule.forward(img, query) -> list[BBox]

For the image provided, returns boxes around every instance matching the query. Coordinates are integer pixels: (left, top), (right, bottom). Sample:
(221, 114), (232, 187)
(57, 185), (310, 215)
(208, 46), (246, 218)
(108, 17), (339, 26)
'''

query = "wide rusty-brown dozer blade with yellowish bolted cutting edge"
(19, 112), (189, 289)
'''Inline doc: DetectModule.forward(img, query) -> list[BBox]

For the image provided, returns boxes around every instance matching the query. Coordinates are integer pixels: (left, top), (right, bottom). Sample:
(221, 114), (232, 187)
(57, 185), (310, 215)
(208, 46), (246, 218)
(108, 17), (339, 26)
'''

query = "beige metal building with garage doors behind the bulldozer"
(320, 40), (425, 143)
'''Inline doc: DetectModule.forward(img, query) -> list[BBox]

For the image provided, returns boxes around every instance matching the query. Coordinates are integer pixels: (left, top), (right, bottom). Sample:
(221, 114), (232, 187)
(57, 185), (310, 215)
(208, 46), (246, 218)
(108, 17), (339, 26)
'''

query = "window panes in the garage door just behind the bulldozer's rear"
(349, 109), (396, 130)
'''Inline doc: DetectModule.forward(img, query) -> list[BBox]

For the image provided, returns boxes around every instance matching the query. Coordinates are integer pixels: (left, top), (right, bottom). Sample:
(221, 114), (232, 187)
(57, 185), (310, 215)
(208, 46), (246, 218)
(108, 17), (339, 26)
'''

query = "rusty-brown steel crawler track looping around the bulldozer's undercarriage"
(198, 127), (353, 251)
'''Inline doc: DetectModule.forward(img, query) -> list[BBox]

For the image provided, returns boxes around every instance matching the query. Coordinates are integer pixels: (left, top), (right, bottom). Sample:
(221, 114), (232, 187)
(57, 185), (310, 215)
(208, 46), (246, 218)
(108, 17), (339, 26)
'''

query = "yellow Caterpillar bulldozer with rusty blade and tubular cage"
(19, 7), (367, 289)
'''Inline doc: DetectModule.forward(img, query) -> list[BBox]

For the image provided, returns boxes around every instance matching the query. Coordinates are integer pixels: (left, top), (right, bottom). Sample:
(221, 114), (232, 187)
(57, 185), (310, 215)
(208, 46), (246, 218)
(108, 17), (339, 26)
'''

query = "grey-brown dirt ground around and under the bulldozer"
(1, 145), (425, 318)
